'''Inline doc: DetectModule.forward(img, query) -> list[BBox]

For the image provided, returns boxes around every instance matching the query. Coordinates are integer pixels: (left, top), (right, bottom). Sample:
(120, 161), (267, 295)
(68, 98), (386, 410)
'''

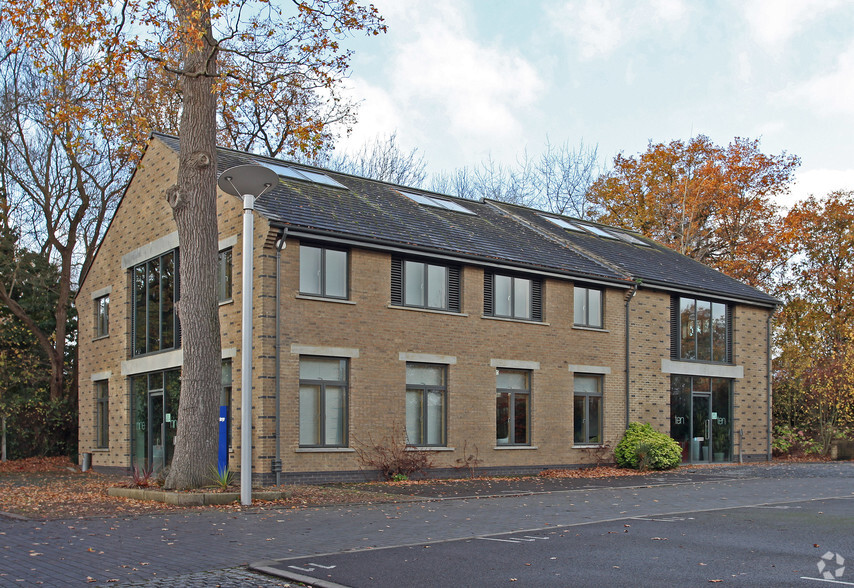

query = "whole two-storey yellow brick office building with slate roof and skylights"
(77, 135), (776, 482)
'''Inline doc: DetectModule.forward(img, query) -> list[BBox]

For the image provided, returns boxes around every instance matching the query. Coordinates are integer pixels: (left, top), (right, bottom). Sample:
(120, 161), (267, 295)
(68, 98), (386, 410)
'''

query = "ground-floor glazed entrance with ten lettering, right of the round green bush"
(670, 376), (732, 463)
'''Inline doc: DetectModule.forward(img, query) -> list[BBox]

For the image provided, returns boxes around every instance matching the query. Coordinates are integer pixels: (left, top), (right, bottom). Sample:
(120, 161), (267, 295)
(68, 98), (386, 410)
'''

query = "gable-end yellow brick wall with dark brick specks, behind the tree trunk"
(76, 139), (269, 467)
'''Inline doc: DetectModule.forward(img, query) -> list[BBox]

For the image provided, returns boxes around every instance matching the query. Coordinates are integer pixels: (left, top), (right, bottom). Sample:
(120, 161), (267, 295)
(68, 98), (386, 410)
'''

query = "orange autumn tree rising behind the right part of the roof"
(587, 135), (800, 288)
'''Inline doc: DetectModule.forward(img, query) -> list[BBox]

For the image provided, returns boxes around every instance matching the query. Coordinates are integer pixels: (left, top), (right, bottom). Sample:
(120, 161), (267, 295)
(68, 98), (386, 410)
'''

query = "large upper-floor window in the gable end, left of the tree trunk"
(131, 250), (180, 355)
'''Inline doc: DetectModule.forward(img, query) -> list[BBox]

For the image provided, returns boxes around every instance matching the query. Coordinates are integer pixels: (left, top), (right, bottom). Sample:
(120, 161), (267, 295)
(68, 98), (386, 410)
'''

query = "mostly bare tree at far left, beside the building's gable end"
(0, 32), (140, 401)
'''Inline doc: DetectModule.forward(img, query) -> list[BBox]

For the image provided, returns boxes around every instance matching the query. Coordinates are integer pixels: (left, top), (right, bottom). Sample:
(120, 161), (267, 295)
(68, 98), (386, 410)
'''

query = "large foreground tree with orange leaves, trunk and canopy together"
(0, 0), (384, 488)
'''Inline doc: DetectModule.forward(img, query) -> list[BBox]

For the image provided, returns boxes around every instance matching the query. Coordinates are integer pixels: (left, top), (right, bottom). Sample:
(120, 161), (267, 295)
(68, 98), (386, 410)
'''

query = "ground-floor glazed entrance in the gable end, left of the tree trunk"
(131, 369), (181, 472)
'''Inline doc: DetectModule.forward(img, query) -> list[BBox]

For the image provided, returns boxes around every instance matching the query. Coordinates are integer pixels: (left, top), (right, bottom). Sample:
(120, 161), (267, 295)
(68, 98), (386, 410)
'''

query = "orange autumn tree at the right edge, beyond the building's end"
(774, 191), (854, 449)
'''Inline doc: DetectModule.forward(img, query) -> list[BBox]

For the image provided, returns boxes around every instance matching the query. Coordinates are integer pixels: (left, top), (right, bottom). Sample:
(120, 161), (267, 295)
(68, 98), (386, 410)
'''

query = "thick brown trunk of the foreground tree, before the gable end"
(165, 0), (222, 489)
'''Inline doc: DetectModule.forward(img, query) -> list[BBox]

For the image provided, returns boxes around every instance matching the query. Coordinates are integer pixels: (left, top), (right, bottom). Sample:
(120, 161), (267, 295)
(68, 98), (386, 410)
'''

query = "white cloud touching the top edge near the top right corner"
(735, 0), (839, 53)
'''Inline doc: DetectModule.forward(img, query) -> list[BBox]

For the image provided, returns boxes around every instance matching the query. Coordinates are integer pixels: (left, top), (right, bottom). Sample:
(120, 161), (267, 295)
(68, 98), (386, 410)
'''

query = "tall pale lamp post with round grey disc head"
(217, 164), (279, 505)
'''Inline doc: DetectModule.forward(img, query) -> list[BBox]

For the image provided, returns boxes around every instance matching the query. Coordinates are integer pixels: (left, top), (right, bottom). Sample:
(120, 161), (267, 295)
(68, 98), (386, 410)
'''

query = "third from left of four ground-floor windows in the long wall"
(495, 369), (531, 445)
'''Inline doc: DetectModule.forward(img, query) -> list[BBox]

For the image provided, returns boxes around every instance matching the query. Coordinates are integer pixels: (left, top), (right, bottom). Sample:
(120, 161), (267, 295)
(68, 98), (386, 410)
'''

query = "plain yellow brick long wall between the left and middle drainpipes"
(274, 239), (625, 471)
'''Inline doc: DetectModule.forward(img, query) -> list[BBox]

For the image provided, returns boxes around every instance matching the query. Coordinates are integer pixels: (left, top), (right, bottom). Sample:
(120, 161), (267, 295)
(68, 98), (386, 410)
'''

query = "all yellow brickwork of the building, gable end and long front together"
(77, 140), (767, 475)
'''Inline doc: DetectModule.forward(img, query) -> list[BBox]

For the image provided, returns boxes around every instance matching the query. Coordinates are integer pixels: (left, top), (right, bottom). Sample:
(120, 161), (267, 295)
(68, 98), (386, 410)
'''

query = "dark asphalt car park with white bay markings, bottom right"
(250, 496), (854, 588)
